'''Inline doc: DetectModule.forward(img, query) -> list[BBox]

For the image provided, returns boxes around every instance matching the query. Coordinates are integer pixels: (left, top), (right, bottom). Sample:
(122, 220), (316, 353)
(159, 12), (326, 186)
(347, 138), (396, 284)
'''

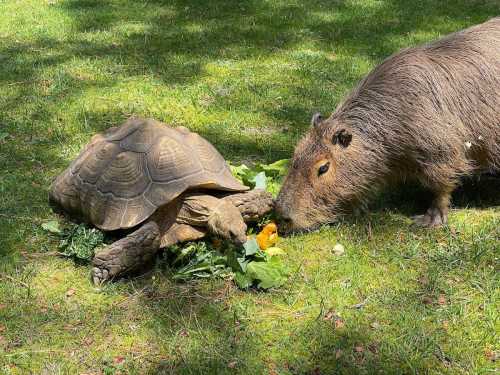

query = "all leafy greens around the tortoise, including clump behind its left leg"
(42, 160), (288, 289)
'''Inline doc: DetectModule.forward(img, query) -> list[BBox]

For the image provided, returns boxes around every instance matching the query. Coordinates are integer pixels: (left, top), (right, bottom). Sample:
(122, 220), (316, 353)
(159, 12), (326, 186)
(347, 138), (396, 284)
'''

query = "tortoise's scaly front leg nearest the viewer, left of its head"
(92, 221), (160, 285)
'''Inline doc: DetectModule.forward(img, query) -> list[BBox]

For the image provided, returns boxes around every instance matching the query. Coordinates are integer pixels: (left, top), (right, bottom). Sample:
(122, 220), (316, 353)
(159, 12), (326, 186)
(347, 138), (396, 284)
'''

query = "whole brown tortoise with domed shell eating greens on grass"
(49, 117), (273, 284)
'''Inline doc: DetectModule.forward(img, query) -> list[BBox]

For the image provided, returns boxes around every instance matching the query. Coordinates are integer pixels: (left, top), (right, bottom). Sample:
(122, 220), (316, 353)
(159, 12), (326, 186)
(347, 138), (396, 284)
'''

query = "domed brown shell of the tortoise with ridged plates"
(49, 118), (248, 230)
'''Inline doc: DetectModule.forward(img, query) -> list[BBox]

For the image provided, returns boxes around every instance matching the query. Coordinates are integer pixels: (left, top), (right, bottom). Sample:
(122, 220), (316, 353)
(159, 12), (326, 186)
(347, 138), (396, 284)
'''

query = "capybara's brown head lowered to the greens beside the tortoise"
(276, 114), (373, 231)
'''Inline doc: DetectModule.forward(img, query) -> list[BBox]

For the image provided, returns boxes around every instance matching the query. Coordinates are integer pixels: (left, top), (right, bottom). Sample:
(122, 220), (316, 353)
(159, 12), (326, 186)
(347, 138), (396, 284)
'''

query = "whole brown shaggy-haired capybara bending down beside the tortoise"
(276, 18), (500, 230)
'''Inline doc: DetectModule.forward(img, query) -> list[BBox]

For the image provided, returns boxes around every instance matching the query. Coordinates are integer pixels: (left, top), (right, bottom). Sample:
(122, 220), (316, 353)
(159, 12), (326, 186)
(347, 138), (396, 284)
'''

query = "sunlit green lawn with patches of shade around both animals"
(0, 0), (500, 375)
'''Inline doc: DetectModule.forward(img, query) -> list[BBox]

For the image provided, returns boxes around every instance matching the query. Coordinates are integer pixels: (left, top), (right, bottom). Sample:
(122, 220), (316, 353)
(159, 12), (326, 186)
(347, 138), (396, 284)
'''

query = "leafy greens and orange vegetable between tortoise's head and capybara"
(167, 160), (288, 289)
